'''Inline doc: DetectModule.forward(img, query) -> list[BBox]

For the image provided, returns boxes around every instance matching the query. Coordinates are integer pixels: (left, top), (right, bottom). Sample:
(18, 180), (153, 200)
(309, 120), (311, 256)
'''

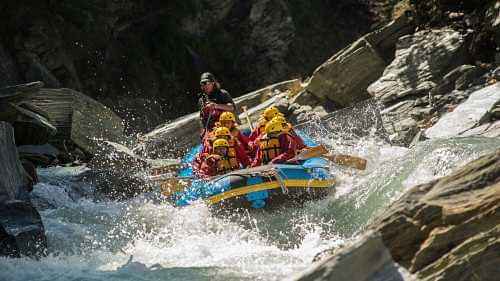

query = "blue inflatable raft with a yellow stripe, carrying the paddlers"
(159, 130), (335, 209)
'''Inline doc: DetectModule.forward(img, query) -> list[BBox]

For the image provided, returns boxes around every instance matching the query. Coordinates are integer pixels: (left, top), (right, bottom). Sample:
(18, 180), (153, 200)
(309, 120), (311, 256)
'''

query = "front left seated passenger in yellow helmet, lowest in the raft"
(200, 139), (241, 178)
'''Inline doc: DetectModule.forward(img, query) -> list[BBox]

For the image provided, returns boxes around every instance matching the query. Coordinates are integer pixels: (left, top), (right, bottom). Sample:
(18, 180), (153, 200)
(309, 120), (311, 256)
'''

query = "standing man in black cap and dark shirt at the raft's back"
(198, 72), (236, 138)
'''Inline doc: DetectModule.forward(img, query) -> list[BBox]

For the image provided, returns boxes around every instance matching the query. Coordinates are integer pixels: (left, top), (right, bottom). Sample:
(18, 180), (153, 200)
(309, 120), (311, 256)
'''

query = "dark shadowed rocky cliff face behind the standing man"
(0, 0), (384, 129)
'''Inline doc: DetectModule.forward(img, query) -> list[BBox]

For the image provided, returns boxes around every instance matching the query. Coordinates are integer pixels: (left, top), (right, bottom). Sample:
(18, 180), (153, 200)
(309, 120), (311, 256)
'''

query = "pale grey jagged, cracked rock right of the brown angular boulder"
(368, 29), (466, 103)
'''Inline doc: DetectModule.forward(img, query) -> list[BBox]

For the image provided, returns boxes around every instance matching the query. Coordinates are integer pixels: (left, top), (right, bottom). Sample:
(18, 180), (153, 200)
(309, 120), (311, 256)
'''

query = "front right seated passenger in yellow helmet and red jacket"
(252, 118), (298, 167)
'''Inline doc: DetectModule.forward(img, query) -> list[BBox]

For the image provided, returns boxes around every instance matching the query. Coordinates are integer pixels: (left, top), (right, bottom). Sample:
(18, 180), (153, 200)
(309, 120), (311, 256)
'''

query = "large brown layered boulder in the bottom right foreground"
(300, 150), (500, 281)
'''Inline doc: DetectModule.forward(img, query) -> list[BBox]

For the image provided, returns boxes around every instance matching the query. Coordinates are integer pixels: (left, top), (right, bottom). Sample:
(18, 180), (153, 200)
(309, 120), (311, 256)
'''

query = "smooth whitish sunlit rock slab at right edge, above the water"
(425, 83), (500, 138)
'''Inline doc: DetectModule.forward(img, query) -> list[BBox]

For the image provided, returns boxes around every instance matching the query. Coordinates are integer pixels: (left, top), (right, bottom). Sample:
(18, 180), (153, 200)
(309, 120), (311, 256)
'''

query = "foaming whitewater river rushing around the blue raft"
(0, 135), (500, 281)
